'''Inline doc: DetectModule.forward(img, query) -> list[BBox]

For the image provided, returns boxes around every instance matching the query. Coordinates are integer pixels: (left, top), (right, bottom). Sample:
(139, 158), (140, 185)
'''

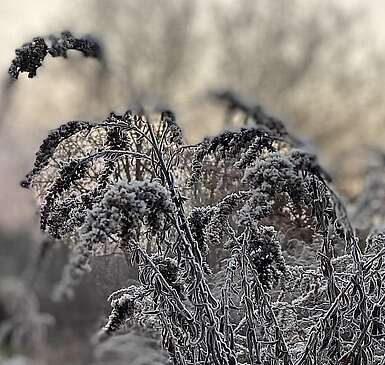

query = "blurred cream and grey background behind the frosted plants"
(0, 0), (385, 364)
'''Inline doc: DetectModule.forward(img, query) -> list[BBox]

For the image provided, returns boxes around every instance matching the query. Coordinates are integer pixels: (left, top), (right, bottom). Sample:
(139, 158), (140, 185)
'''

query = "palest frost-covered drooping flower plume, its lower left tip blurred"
(53, 181), (174, 301)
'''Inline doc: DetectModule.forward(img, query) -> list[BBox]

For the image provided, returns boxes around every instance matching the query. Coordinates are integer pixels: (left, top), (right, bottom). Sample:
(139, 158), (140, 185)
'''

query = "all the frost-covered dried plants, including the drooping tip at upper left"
(5, 35), (385, 365)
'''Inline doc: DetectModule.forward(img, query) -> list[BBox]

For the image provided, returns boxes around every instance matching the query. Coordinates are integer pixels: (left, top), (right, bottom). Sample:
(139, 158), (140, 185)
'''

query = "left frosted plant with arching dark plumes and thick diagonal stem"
(42, 110), (240, 364)
